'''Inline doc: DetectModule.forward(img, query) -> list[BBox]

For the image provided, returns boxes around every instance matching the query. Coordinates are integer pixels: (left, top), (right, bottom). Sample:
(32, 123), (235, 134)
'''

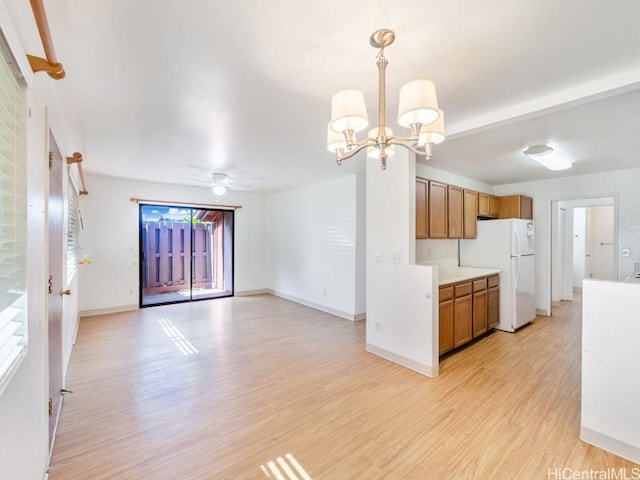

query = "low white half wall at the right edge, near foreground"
(580, 279), (640, 463)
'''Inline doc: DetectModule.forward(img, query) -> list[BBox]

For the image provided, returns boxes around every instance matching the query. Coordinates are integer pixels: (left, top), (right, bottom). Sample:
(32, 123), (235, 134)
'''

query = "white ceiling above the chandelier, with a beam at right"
(2, 0), (640, 192)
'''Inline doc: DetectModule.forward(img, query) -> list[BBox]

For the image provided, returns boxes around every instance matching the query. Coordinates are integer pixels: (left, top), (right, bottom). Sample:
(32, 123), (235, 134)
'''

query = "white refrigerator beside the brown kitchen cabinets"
(460, 218), (536, 332)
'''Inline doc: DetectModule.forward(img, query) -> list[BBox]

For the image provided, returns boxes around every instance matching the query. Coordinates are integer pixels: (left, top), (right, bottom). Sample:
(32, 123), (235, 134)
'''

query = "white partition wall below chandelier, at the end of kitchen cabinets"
(366, 149), (438, 376)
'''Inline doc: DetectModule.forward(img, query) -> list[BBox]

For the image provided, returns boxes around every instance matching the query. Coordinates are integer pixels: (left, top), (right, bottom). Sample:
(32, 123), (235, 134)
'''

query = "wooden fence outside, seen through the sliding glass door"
(142, 221), (215, 293)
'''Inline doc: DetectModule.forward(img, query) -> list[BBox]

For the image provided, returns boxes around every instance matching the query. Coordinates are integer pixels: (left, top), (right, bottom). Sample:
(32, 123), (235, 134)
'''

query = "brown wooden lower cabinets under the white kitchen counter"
(438, 275), (500, 355)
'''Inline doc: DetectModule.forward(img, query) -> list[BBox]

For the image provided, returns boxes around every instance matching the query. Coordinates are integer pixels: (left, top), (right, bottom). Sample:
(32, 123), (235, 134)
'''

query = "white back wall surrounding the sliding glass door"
(79, 175), (266, 315)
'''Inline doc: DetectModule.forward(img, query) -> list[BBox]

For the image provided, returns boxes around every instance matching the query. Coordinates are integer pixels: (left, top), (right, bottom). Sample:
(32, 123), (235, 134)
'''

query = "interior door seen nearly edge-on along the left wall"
(48, 133), (64, 447)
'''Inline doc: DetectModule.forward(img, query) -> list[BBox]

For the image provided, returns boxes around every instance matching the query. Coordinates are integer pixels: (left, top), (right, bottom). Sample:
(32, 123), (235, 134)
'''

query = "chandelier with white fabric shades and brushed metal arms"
(327, 29), (444, 170)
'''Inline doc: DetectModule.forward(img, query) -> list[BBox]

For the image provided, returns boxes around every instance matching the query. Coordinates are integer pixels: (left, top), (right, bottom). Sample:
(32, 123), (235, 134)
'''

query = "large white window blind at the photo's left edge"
(0, 31), (27, 393)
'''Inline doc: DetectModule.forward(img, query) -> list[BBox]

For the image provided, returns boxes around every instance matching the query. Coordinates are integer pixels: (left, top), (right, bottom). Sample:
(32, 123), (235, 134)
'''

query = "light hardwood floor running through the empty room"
(49, 295), (640, 480)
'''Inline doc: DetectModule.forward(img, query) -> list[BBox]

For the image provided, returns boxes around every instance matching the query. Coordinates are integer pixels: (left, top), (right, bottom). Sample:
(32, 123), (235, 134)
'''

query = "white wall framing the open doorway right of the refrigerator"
(495, 168), (640, 314)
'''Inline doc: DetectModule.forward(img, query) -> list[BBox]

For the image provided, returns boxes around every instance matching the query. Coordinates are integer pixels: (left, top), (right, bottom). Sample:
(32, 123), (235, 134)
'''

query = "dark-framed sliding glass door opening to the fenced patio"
(139, 204), (234, 307)
